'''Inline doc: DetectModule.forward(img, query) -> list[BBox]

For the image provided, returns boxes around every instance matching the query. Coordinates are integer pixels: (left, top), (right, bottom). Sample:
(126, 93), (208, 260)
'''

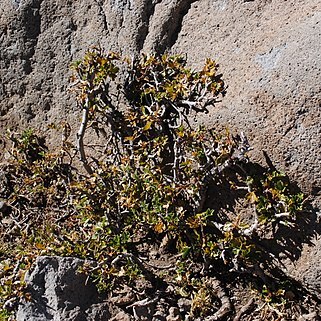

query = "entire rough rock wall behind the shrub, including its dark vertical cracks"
(0, 0), (321, 320)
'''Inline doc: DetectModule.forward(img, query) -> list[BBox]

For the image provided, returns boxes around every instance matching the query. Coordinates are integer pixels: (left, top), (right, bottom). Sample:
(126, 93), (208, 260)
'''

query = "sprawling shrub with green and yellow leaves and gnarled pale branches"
(0, 48), (303, 316)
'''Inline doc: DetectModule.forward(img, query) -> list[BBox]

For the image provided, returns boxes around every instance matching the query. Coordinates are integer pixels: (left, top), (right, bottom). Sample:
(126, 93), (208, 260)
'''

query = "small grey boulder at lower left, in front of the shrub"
(16, 257), (110, 321)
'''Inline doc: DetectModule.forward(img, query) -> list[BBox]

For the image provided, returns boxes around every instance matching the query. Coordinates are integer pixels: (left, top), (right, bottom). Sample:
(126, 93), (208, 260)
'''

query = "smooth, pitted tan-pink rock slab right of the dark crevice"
(166, 0), (321, 192)
